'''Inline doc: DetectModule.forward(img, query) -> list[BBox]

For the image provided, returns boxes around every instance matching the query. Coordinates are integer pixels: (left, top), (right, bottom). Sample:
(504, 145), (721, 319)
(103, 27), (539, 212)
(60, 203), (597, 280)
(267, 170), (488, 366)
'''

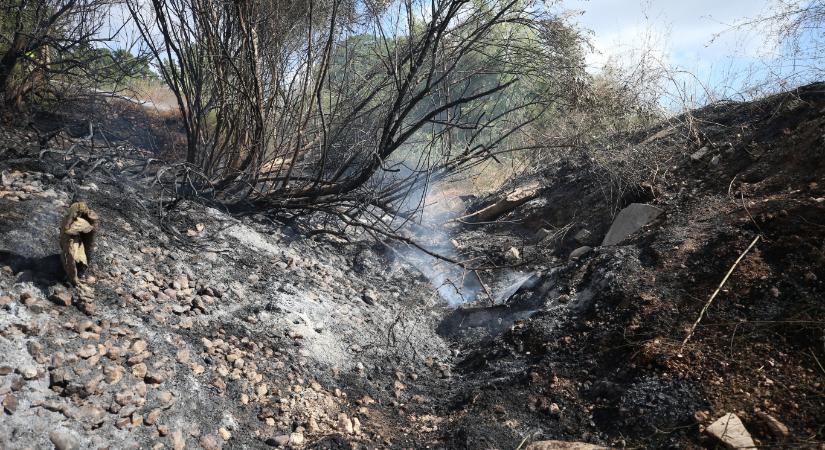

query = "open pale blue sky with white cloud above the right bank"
(561, 0), (796, 101)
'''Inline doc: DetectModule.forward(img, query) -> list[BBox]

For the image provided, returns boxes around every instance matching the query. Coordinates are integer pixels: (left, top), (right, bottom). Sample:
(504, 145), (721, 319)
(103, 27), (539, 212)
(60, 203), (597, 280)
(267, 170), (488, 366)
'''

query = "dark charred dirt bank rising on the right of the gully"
(434, 84), (825, 448)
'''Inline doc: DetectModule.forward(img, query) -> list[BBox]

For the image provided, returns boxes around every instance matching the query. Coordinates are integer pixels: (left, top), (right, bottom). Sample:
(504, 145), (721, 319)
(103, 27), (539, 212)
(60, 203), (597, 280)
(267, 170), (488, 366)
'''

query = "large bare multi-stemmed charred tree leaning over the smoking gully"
(127, 0), (580, 232)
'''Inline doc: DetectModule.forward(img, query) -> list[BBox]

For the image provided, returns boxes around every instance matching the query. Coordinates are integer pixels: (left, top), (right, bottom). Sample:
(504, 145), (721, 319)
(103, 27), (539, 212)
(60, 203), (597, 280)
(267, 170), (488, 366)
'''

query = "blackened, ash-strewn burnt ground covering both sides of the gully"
(0, 84), (825, 449)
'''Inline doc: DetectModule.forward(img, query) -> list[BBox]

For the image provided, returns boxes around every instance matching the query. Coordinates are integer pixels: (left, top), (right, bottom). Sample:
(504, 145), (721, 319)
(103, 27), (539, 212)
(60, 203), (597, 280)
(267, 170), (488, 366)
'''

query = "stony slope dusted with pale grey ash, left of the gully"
(0, 124), (452, 449)
